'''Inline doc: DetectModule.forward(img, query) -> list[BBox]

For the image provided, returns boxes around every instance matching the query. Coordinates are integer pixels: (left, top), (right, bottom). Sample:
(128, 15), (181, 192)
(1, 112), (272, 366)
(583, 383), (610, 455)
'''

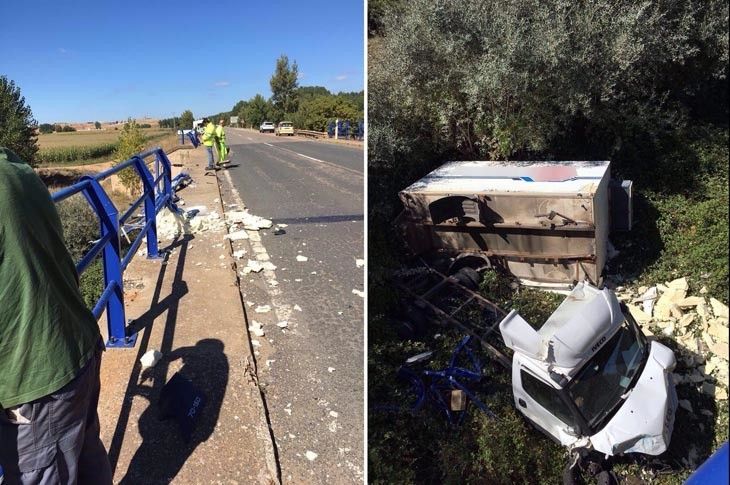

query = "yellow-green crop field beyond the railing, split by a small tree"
(38, 128), (177, 167)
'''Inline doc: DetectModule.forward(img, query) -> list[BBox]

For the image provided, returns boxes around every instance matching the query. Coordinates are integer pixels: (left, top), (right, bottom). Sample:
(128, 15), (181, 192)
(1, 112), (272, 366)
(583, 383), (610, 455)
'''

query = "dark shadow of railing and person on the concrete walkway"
(109, 235), (229, 484)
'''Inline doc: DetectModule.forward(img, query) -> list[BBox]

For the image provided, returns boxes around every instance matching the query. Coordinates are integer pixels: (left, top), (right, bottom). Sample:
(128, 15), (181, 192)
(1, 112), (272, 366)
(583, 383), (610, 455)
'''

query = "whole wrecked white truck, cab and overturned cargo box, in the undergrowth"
(396, 161), (677, 455)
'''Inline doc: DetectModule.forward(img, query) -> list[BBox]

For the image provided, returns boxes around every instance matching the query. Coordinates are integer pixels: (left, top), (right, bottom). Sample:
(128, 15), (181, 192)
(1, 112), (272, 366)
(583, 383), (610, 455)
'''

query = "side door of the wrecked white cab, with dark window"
(512, 361), (581, 446)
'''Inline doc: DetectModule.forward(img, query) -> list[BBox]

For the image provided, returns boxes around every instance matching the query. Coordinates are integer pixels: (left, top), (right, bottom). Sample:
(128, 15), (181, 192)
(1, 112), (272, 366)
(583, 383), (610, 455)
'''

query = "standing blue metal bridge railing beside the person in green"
(52, 148), (180, 347)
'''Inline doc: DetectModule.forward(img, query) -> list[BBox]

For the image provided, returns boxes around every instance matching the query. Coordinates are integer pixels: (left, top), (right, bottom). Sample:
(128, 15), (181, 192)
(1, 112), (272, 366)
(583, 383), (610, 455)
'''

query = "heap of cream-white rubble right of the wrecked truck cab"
(617, 278), (730, 400)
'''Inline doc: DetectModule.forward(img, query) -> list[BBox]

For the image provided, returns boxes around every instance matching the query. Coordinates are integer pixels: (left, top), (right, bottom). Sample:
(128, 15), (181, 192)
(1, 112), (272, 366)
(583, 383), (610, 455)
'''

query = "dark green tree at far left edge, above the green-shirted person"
(0, 76), (38, 165)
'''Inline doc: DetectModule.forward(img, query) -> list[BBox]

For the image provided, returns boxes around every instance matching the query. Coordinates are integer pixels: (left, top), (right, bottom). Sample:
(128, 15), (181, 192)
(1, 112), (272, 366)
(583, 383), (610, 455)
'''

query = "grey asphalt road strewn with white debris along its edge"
(219, 129), (364, 483)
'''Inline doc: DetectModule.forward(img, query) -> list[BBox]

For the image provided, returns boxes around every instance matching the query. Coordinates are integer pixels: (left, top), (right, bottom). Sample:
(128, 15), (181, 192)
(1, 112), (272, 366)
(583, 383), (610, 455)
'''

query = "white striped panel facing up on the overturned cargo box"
(403, 160), (610, 194)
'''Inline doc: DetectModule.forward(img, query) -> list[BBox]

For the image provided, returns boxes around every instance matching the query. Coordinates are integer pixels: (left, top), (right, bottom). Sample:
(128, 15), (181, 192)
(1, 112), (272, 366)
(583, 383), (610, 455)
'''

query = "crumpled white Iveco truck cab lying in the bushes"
(499, 283), (677, 455)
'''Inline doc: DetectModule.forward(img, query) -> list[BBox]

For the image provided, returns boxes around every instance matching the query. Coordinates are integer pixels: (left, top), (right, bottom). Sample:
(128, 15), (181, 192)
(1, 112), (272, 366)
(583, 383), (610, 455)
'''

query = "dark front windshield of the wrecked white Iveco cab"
(568, 321), (648, 428)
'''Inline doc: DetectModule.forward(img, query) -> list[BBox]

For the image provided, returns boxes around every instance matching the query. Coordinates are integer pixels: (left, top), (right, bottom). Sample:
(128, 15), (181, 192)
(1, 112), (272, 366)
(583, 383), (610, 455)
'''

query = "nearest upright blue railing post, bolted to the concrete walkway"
(81, 176), (136, 347)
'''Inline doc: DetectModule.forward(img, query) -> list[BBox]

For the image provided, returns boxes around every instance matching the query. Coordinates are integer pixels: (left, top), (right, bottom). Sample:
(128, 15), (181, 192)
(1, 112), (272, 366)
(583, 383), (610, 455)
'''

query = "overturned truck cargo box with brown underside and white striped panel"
(398, 161), (630, 287)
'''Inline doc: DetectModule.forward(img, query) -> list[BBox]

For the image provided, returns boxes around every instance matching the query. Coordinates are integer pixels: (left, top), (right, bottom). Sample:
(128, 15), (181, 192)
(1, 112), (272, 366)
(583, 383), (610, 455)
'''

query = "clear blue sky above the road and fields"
(0, 0), (364, 123)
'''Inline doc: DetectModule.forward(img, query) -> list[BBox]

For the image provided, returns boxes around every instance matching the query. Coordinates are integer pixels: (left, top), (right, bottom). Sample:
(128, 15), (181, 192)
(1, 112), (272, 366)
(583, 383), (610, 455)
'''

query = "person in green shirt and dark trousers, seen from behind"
(0, 147), (111, 485)
